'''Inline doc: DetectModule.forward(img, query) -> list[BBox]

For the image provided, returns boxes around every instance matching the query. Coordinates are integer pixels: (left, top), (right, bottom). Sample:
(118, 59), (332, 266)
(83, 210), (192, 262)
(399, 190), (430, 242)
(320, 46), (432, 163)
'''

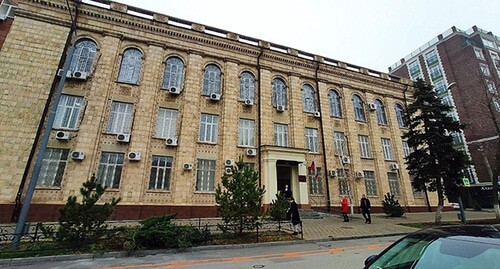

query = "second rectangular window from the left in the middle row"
(106, 101), (134, 134)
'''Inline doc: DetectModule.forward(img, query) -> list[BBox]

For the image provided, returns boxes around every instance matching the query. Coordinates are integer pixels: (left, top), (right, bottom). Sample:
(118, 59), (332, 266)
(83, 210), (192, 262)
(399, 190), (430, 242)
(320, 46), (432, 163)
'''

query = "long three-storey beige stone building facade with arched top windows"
(0, 0), (430, 222)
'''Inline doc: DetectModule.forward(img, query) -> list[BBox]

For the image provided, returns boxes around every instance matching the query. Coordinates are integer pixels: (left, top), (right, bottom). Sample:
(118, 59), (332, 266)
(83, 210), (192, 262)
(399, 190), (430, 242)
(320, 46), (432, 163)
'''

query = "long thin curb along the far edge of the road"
(0, 233), (408, 267)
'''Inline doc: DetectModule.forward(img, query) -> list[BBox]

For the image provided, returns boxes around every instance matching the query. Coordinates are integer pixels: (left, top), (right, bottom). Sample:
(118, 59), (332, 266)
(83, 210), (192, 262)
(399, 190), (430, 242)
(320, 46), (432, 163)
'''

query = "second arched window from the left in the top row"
(118, 49), (142, 84)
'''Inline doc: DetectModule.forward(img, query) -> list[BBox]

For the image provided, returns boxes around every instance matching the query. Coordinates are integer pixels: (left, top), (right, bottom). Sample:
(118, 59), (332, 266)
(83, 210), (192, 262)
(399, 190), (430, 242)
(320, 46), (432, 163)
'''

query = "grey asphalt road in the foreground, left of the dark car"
(3, 236), (401, 269)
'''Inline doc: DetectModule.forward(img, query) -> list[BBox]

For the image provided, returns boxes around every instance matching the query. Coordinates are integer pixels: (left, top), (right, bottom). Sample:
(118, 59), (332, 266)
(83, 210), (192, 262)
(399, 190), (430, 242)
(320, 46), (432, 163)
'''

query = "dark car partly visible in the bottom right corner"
(364, 225), (500, 269)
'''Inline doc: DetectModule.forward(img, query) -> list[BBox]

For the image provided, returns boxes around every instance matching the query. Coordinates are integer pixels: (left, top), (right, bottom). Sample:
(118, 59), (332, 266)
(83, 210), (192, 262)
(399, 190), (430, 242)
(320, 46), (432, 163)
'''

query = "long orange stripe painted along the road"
(99, 243), (389, 269)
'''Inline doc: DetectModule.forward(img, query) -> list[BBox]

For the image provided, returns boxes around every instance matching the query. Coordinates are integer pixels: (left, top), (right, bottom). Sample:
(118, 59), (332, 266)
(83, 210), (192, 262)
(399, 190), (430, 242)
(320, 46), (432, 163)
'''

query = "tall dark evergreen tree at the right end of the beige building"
(403, 79), (468, 224)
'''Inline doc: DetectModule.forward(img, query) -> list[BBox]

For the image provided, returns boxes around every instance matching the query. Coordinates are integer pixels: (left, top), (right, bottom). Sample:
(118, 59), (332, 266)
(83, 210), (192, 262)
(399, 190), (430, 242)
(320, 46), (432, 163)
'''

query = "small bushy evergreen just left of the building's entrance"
(215, 158), (265, 234)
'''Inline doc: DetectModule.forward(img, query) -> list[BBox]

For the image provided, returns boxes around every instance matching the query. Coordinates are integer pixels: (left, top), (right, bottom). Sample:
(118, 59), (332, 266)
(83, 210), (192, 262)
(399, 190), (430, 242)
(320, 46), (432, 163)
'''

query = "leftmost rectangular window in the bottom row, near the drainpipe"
(36, 148), (69, 187)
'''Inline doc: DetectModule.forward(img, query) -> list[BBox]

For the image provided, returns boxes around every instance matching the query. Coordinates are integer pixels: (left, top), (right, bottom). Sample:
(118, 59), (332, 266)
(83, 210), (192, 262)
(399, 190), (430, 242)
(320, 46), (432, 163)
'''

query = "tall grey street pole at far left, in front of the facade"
(12, 0), (80, 250)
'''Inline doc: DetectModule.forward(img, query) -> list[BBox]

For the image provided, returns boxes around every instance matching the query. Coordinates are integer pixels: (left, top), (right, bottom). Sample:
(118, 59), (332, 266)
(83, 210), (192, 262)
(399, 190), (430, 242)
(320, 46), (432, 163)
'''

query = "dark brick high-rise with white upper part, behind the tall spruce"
(389, 26), (500, 205)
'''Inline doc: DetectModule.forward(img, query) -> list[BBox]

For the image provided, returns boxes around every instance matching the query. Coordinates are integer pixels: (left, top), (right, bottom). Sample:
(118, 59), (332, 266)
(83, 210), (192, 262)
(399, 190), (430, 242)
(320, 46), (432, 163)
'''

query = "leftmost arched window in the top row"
(69, 39), (97, 73)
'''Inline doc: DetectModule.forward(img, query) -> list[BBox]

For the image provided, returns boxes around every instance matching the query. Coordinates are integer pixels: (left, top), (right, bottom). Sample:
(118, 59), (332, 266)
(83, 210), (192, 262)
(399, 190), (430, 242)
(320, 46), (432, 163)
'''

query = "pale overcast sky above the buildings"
(111, 0), (500, 72)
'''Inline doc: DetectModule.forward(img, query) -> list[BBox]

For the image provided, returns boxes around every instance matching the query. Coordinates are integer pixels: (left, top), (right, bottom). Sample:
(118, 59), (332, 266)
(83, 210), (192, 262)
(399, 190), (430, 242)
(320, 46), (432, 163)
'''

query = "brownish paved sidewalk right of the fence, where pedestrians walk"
(303, 210), (495, 240)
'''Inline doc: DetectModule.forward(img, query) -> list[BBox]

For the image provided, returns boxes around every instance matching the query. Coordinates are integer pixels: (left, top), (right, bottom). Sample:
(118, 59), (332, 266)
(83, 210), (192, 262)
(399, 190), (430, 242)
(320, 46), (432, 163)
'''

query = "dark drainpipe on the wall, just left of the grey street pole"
(10, 1), (78, 222)
